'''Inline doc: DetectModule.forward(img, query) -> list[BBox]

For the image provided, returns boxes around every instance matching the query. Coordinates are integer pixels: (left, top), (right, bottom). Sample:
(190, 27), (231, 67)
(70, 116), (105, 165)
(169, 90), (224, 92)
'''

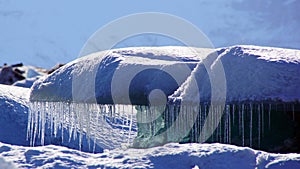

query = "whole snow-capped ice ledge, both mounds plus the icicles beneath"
(28, 46), (300, 151)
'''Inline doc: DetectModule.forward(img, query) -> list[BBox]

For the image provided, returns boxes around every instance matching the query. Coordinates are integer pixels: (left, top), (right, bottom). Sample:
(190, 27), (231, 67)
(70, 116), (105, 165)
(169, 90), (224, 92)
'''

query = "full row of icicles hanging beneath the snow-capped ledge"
(27, 102), (294, 149)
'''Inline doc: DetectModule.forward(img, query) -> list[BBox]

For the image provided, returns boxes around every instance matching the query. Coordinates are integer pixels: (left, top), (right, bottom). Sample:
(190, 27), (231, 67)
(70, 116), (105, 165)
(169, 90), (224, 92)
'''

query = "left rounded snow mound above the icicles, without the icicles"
(30, 47), (211, 104)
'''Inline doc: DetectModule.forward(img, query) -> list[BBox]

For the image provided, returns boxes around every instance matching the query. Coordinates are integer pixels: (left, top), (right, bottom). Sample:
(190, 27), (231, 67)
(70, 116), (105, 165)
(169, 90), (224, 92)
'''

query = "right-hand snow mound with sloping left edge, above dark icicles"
(170, 46), (300, 103)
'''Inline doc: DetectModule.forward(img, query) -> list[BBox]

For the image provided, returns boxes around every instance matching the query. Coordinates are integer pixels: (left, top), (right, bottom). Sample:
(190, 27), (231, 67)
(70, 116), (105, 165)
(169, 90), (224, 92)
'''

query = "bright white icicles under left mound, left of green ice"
(27, 102), (137, 150)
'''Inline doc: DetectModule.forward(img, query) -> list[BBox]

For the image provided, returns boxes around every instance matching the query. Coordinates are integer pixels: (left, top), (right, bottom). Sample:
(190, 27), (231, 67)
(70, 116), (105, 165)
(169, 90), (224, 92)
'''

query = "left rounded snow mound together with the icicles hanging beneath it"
(28, 47), (206, 148)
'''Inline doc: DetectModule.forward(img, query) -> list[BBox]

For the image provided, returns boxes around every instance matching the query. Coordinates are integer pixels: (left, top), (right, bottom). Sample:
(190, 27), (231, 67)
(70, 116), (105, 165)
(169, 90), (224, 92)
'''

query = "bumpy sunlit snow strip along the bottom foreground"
(0, 143), (300, 169)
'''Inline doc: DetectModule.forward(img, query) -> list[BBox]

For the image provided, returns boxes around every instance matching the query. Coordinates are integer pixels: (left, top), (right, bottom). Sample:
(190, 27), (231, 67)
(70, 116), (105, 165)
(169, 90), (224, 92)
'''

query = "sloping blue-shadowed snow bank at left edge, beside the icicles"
(0, 85), (29, 145)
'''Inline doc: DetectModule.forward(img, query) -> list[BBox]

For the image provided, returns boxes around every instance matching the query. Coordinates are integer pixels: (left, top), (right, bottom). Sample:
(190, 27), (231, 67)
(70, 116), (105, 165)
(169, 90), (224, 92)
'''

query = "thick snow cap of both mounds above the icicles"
(30, 46), (300, 104)
